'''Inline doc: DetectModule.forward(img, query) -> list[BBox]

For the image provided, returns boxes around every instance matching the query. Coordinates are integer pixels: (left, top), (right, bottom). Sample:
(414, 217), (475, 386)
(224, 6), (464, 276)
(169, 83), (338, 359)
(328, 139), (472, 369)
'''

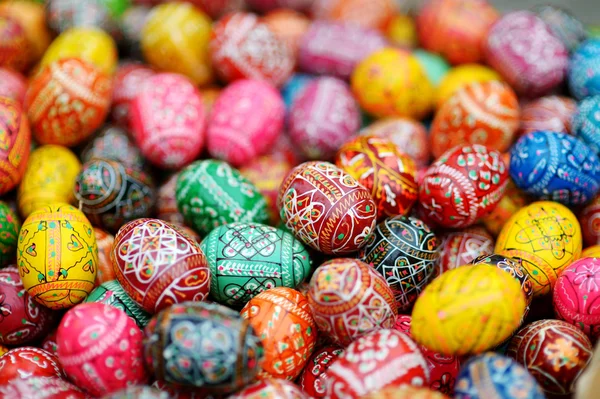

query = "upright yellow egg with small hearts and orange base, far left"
(17, 203), (98, 309)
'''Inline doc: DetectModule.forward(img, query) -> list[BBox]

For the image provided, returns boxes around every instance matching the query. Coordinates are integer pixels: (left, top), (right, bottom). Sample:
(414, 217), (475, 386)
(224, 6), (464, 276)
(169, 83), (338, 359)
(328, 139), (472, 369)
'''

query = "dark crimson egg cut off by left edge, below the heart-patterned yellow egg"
(0, 266), (55, 346)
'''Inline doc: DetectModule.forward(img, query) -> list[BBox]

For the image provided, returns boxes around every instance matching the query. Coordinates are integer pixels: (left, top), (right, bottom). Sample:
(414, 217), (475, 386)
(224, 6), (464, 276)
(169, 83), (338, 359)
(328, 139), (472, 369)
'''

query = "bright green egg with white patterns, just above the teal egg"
(175, 160), (269, 236)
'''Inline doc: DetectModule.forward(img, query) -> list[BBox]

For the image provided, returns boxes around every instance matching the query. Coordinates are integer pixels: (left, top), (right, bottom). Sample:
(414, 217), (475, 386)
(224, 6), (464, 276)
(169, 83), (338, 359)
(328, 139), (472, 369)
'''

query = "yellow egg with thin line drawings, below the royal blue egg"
(495, 201), (582, 296)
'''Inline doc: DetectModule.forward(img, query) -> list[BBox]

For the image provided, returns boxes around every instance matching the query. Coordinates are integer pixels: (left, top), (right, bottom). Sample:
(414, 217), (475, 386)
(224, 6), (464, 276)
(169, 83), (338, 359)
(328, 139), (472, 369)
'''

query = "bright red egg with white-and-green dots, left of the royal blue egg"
(419, 144), (508, 228)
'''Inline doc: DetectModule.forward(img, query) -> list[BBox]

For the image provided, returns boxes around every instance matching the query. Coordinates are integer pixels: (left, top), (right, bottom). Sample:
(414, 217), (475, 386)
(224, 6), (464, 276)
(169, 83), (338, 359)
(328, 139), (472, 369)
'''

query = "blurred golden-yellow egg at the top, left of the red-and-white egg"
(140, 2), (213, 85)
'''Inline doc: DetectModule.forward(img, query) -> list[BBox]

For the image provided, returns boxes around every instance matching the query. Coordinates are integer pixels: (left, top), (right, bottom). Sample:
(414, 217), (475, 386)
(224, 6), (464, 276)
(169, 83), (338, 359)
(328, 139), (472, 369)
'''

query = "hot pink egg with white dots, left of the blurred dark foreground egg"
(56, 303), (148, 396)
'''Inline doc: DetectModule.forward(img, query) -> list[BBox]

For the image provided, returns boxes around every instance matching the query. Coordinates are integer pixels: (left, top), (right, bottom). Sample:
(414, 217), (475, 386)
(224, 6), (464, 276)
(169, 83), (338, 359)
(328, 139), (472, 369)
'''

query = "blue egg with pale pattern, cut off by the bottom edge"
(454, 352), (545, 399)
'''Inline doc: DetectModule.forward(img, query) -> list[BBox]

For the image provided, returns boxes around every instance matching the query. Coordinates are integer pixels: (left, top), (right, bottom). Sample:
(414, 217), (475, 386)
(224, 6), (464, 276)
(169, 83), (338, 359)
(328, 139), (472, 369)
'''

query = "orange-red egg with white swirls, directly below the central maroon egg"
(308, 258), (398, 346)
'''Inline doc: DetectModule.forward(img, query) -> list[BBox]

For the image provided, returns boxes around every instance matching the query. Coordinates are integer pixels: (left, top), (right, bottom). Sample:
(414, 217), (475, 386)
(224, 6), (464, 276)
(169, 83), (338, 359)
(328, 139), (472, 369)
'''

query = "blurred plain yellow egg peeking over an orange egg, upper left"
(41, 27), (117, 75)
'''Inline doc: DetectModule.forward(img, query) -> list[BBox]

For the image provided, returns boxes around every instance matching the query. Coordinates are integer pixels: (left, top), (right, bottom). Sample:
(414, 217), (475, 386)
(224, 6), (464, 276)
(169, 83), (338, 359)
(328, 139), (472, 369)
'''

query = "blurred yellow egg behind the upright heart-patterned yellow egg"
(17, 145), (81, 217)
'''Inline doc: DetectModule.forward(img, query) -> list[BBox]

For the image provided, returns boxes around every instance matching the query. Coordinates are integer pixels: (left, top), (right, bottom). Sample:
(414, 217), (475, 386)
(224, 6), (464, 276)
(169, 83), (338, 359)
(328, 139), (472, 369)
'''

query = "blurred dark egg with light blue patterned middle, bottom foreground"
(144, 302), (263, 393)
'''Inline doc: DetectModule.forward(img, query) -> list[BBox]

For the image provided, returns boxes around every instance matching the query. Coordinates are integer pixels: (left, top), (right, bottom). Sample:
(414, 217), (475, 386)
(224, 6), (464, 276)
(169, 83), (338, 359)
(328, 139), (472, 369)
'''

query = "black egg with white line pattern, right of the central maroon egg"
(358, 216), (440, 311)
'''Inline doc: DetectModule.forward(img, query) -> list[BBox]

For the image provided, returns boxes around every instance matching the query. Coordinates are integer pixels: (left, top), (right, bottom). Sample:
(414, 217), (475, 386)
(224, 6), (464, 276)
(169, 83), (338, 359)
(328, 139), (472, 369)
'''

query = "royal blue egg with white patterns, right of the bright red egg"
(509, 131), (600, 205)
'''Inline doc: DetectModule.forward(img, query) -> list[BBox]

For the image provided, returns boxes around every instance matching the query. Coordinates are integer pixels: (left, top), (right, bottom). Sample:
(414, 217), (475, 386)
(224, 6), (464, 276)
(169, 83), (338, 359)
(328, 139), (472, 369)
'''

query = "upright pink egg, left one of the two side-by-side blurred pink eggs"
(130, 73), (206, 169)
